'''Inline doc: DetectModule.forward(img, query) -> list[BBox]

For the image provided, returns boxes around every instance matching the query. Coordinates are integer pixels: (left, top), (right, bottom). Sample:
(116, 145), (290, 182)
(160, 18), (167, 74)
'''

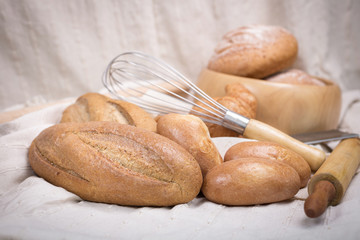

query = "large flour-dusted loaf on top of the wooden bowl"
(208, 25), (298, 79)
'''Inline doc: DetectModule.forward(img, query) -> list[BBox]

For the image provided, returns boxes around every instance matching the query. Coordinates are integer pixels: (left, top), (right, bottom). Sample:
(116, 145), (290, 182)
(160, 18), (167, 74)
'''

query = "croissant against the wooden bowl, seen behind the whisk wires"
(194, 83), (257, 137)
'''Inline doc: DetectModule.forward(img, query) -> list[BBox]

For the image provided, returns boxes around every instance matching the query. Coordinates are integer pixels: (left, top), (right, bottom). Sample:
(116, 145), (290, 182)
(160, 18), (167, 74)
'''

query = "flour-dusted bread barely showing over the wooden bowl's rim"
(265, 69), (326, 86)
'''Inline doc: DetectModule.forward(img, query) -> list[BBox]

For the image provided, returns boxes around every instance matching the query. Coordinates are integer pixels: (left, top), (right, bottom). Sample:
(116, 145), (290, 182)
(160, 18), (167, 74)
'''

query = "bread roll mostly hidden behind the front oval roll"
(224, 141), (311, 187)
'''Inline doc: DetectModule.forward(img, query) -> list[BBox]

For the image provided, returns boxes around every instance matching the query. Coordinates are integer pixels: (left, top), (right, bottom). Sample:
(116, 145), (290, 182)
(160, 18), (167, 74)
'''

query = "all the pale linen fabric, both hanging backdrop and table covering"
(0, 0), (360, 240)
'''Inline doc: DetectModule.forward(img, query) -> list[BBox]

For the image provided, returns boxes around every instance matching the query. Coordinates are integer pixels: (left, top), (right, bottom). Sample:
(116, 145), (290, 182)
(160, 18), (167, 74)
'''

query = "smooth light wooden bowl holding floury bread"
(197, 69), (341, 134)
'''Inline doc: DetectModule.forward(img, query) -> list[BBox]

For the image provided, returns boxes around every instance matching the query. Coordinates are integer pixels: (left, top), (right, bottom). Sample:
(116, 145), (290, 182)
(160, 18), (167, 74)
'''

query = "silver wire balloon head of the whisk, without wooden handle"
(102, 52), (248, 133)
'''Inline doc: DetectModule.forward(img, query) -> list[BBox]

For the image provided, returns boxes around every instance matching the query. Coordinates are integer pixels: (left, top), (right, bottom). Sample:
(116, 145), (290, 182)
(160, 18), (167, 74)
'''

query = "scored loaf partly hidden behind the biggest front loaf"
(61, 93), (156, 132)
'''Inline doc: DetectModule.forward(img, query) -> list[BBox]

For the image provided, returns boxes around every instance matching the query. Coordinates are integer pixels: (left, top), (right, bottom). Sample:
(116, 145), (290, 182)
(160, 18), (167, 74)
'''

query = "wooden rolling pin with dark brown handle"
(304, 138), (360, 218)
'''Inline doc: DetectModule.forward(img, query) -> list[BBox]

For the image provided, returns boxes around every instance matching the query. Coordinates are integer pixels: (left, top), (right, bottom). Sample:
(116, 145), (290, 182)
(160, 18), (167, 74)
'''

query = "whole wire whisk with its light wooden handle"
(102, 52), (325, 170)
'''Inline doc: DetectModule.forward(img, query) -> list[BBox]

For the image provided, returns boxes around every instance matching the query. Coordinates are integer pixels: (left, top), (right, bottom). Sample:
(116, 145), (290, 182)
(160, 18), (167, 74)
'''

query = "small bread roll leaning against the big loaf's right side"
(157, 113), (223, 176)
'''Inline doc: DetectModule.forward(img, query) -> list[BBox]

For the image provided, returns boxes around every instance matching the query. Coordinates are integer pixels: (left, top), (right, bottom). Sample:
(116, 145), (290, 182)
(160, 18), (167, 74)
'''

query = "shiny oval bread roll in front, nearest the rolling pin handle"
(202, 158), (300, 205)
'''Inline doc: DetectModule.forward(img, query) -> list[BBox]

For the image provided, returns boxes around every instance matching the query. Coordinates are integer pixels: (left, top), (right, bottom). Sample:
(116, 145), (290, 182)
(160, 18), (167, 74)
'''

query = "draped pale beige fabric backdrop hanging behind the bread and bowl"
(0, 0), (360, 111)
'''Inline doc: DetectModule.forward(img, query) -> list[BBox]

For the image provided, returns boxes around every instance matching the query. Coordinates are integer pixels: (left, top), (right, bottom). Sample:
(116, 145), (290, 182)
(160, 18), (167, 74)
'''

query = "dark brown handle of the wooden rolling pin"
(304, 180), (336, 218)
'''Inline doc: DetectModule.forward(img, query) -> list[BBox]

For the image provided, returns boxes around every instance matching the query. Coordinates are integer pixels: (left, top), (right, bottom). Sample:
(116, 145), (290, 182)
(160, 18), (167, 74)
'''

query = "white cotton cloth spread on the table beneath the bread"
(0, 91), (360, 240)
